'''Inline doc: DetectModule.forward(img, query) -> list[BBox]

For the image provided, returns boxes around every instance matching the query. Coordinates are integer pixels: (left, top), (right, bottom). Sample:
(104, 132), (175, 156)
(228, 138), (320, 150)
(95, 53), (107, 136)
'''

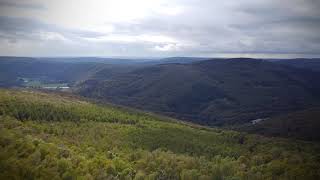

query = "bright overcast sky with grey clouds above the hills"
(0, 0), (320, 58)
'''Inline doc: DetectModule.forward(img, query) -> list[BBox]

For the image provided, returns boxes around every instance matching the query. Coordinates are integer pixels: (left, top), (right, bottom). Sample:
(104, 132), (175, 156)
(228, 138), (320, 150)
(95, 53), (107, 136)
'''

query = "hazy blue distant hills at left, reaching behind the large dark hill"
(0, 56), (210, 87)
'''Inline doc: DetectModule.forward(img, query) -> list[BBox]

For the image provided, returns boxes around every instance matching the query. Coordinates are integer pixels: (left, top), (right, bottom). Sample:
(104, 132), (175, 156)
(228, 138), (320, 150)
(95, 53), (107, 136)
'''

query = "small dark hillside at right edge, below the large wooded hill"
(239, 108), (320, 141)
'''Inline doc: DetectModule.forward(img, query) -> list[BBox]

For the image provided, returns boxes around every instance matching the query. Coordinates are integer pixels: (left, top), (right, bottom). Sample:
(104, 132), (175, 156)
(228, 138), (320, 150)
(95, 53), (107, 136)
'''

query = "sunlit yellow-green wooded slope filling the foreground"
(0, 90), (320, 180)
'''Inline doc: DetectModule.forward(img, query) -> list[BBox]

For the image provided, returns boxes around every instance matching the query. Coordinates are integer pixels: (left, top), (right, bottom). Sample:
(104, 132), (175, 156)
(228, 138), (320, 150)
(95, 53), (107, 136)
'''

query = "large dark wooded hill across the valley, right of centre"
(78, 58), (320, 125)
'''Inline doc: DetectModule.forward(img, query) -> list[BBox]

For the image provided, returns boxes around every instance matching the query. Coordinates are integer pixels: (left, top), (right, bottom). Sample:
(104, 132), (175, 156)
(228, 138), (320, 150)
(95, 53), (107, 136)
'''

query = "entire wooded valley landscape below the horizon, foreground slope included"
(0, 58), (320, 179)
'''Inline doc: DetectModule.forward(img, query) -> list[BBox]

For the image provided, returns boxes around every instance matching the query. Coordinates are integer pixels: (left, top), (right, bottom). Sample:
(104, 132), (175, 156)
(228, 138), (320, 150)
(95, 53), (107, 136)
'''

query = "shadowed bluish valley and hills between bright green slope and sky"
(0, 57), (320, 139)
